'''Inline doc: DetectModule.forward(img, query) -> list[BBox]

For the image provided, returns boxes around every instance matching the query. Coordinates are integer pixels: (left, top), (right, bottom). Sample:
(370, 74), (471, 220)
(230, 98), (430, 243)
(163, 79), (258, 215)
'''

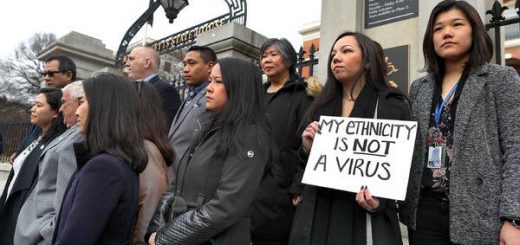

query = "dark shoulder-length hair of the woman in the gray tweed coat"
(423, 0), (493, 81)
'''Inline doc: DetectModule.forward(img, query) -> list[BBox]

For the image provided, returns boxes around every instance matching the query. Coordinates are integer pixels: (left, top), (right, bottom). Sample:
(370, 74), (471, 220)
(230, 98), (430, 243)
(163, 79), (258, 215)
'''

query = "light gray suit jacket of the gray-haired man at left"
(13, 125), (83, 245)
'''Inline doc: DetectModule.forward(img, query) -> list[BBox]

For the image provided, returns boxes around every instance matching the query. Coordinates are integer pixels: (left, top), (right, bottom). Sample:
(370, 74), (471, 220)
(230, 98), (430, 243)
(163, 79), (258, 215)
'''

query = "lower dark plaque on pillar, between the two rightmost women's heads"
(383, 45), (410, 94)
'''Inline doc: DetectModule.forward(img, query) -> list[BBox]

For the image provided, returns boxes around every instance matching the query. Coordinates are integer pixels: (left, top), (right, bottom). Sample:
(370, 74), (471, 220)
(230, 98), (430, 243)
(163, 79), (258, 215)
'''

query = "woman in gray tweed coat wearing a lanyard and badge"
(401, 0), (520, 245)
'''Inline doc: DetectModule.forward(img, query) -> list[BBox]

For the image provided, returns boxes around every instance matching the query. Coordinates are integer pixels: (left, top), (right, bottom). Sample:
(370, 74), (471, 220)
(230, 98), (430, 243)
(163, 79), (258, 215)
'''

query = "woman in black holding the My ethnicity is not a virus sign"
(290, 32), (410, 245)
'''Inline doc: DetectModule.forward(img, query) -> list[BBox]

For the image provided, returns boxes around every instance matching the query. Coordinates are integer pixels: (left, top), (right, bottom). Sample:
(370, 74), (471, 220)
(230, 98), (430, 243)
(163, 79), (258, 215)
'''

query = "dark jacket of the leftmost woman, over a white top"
(0, 140), (44, 245)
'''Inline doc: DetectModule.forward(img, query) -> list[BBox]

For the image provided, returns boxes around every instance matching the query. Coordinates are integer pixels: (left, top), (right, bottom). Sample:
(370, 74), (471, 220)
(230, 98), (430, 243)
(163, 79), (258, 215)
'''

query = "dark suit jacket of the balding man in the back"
(149, 76), (181, 127)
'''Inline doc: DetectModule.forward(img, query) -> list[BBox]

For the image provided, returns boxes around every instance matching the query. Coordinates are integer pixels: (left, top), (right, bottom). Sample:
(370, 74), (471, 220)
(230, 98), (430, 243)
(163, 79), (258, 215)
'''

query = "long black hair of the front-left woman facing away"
(83, 73), (148, 173)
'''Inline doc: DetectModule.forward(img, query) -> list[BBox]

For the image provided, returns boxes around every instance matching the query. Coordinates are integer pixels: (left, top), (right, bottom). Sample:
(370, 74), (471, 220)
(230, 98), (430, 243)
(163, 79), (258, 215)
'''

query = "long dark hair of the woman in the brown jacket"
(135, 81), (175, 166)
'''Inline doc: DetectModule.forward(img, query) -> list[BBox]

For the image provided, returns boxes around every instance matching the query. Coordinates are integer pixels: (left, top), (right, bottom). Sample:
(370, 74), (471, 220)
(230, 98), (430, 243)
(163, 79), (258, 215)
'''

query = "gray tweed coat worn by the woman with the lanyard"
(400, 64), (520, 244)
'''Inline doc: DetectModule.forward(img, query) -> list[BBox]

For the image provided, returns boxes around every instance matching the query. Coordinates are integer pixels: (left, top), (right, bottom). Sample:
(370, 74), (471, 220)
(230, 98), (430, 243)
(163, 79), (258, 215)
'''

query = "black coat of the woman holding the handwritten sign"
(289, 86), (410, 245)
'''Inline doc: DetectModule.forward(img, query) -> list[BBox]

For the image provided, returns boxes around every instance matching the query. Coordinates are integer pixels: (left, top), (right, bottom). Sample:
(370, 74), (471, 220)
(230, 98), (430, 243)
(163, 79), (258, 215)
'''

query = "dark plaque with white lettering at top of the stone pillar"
(365, 0), (419, 29)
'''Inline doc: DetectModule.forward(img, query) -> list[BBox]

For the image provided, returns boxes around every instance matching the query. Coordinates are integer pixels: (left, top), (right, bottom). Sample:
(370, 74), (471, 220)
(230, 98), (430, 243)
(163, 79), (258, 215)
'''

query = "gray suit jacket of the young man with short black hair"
(168, 89), (206, 185)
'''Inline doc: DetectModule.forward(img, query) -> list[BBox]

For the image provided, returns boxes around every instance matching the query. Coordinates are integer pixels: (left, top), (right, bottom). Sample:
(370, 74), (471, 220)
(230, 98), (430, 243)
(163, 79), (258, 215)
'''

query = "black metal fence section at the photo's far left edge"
(0, 122), (32, 162)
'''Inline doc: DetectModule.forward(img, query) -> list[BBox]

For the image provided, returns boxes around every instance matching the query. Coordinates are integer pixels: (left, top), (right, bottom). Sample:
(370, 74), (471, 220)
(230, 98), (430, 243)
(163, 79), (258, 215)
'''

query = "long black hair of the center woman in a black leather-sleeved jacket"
(212, 58), (269, 156)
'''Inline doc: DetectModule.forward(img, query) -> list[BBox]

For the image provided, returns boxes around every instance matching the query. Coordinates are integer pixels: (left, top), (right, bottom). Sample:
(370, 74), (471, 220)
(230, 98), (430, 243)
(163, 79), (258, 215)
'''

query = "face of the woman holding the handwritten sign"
(330, 36), (363, 84)
